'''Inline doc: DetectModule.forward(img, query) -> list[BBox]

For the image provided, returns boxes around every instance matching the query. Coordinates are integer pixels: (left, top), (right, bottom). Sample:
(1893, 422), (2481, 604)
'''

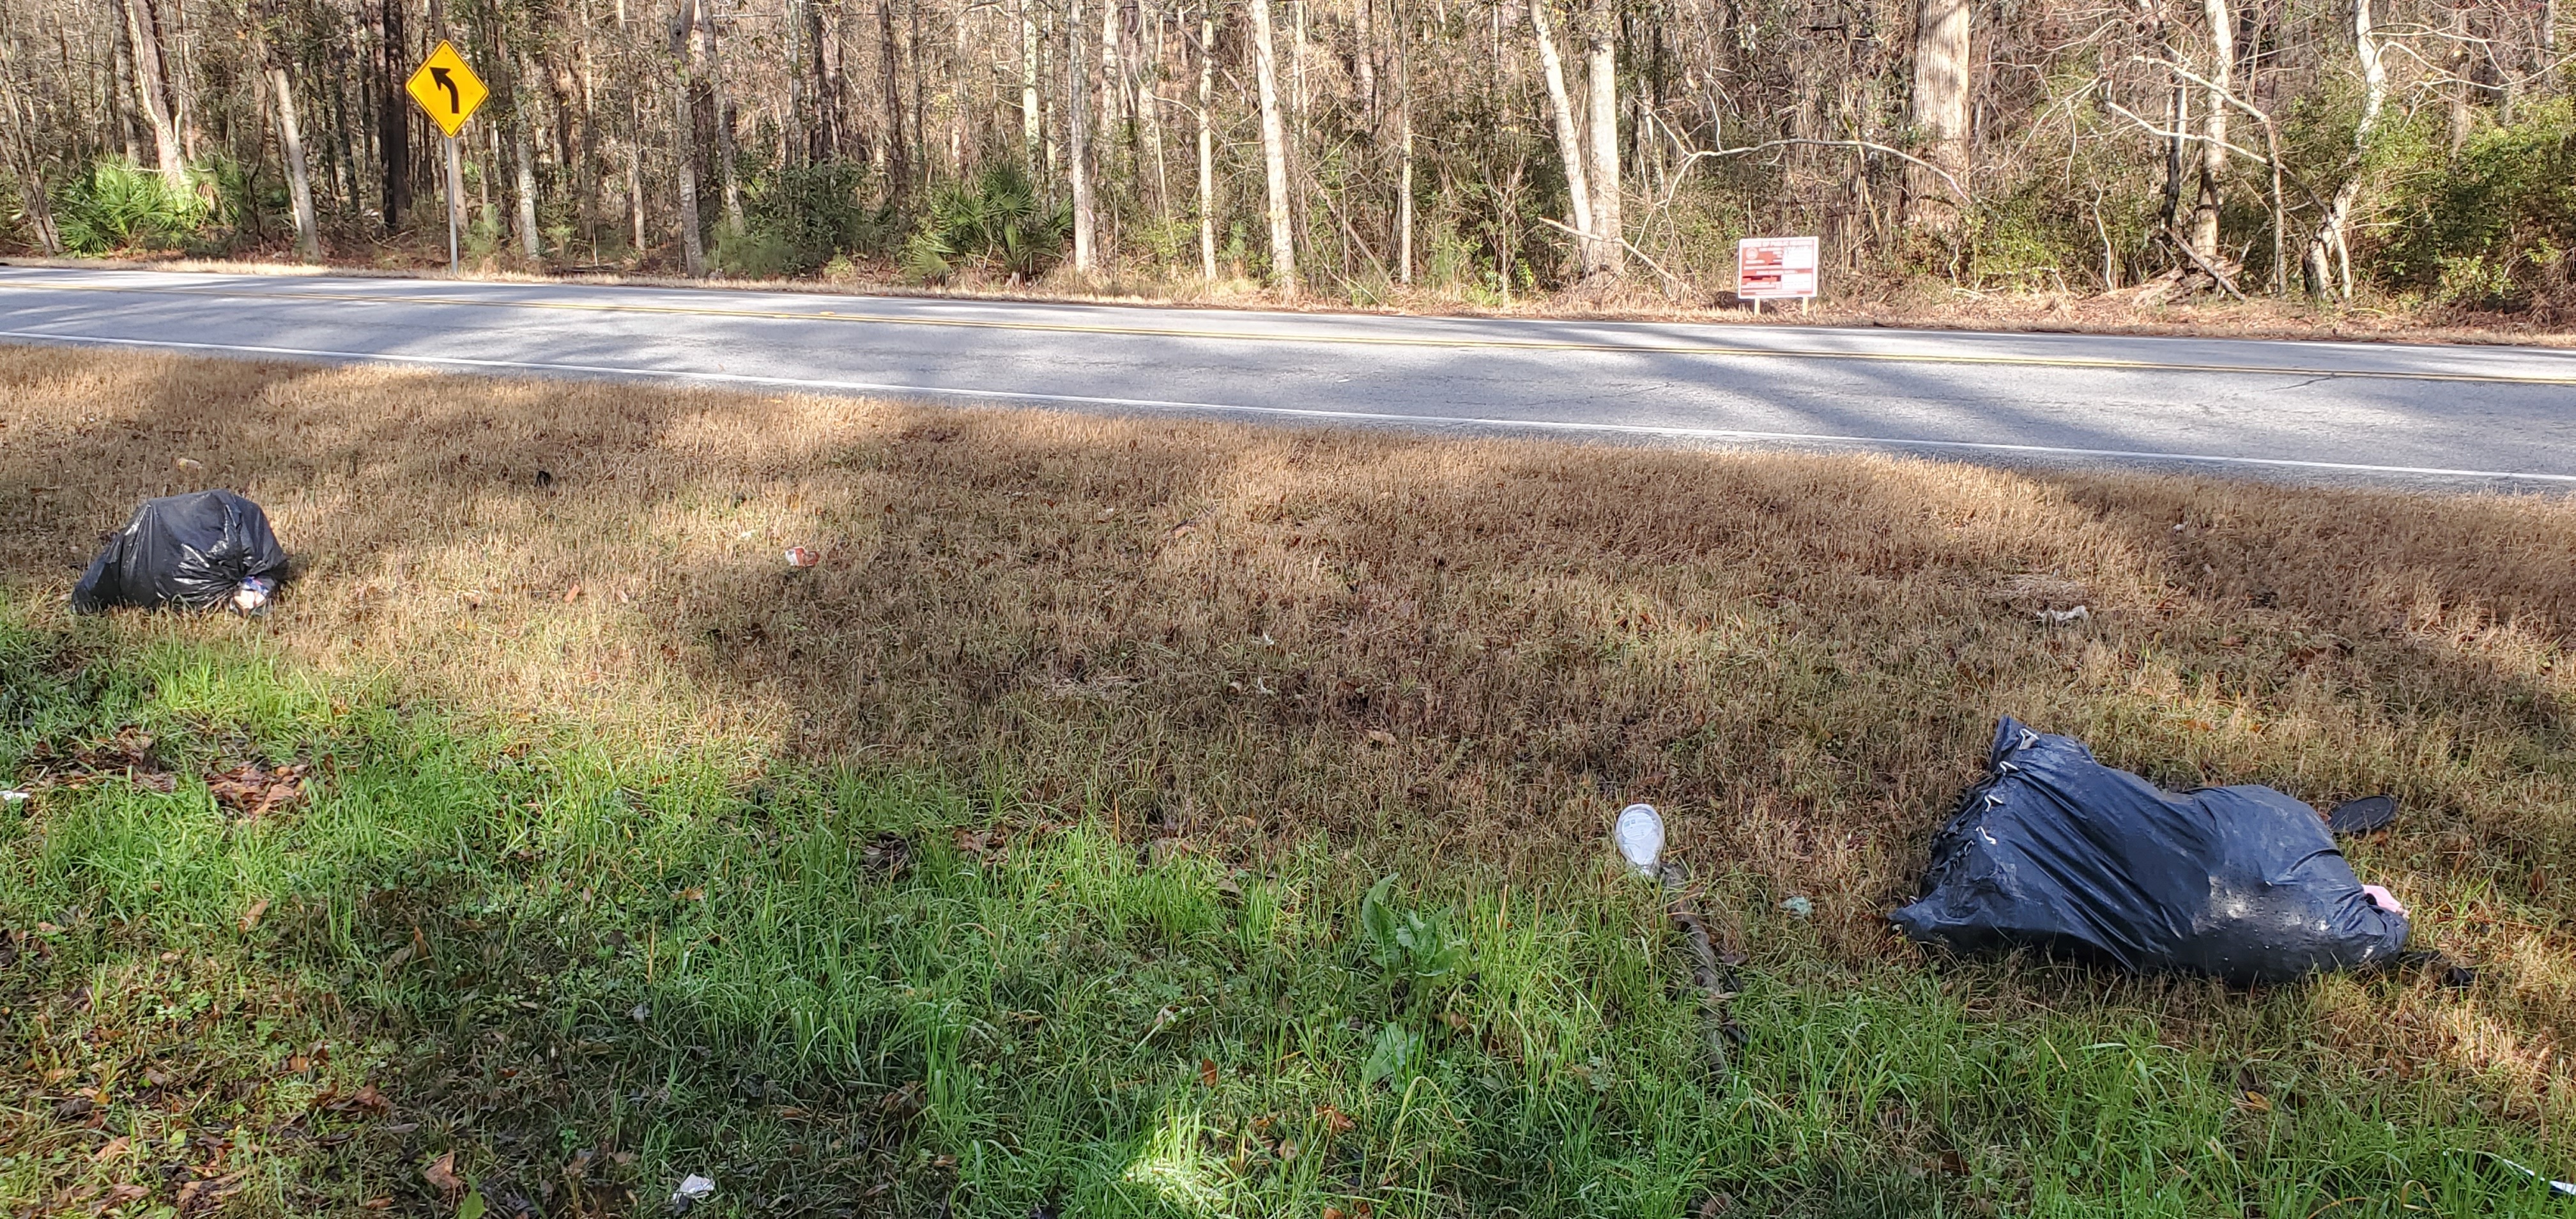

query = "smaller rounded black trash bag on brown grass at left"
(72, 492), (286, 613)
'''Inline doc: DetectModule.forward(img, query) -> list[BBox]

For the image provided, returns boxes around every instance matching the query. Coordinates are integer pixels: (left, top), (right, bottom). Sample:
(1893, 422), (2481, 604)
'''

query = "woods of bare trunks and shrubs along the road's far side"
(0, 0), (2576, 319)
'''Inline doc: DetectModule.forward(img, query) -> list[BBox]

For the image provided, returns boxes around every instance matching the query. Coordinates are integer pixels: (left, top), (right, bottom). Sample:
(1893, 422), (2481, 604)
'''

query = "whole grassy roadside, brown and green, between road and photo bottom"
(0, 348), (2576, 1216)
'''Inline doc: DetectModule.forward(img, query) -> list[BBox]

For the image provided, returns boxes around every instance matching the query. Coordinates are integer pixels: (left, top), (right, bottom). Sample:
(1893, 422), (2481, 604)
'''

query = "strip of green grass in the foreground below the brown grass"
(0, 602), (2568, 1219)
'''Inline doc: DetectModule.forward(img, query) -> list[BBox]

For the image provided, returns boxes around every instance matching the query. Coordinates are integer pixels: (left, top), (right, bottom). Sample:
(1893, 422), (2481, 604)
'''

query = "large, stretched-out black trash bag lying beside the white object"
(1888, 716), (2406, 982)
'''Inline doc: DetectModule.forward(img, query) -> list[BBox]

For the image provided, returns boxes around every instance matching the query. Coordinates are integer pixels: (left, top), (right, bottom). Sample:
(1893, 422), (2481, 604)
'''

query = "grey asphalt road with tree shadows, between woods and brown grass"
(0, 268), (2576, 492)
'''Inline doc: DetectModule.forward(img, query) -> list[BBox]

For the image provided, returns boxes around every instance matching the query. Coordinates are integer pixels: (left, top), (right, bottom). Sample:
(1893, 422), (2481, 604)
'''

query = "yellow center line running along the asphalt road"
(0, 279), (2576, 387)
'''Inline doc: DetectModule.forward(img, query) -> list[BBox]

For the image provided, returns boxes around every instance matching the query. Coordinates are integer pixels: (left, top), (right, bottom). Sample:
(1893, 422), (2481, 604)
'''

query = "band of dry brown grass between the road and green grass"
(15, 348), (2576, 1100)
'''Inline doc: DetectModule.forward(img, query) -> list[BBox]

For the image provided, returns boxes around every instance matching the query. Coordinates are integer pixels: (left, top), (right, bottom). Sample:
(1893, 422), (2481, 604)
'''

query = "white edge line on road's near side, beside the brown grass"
(15, 330), (2576, 484)
